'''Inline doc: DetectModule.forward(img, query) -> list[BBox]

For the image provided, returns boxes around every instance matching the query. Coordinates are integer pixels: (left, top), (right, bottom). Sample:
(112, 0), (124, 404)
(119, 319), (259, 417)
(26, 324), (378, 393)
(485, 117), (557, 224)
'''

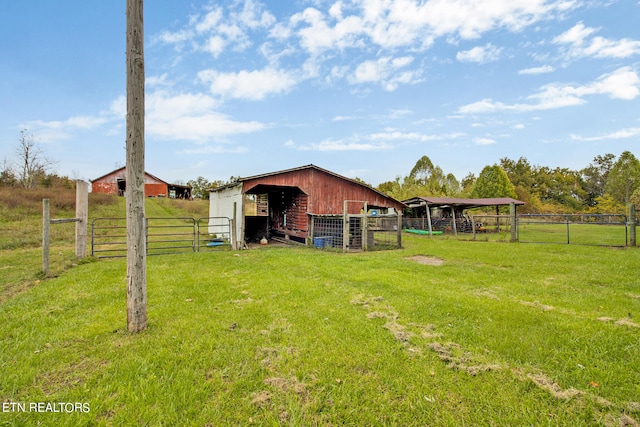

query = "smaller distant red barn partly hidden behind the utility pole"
(91, 167), (191, 199)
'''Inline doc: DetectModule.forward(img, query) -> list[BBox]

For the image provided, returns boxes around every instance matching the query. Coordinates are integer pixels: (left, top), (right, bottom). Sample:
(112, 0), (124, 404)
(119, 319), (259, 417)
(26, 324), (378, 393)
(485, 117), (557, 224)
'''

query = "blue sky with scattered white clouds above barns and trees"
(0, 0), (640, 185)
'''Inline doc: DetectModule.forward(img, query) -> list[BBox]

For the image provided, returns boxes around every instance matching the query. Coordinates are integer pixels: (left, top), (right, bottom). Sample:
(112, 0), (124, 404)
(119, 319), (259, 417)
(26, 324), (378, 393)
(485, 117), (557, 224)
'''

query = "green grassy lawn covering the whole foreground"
(0, 234), (640, 426)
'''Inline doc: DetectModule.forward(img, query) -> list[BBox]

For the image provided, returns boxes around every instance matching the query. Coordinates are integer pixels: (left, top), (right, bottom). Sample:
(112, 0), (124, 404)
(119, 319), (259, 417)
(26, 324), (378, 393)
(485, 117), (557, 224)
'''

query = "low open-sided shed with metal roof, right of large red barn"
(403, 197), (525, 233)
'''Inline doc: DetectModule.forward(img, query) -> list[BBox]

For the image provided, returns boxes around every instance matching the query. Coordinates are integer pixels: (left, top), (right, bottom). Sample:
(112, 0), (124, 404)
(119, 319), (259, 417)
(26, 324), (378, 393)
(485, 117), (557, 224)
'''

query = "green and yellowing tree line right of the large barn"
(376, 151), (640, 213)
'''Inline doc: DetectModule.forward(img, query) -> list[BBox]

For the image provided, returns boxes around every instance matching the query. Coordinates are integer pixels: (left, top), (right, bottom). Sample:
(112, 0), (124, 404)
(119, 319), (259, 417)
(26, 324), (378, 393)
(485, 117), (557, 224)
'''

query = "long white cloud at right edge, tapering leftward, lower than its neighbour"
(458, 67), (640, 114)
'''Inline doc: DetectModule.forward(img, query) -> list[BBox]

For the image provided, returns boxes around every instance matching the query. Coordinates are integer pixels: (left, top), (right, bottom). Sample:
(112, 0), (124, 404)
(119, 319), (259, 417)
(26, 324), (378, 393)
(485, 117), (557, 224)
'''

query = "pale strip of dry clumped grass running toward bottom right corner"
(351, 294), (640, 427)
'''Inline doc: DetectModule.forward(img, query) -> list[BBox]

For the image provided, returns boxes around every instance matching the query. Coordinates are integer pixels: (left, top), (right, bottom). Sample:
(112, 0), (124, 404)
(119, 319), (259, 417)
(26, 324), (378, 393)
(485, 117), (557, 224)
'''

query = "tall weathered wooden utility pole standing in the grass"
(126, 0), (147, 332)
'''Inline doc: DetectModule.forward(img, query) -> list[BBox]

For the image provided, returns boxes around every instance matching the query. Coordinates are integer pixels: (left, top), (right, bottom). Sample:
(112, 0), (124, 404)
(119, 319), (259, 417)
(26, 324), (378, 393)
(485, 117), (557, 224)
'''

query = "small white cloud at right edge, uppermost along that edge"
(553, 22), (640, 58)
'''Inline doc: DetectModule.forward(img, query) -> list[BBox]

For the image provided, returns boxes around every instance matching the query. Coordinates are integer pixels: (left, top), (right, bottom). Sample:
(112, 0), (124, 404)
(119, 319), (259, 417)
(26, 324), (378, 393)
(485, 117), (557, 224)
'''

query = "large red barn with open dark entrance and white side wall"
(209, 165), (404, 247)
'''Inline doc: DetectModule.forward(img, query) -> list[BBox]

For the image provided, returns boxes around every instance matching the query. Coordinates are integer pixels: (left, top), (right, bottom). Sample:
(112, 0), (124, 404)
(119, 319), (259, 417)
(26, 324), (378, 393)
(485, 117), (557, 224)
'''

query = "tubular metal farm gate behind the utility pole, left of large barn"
(91, 218), (231, 258)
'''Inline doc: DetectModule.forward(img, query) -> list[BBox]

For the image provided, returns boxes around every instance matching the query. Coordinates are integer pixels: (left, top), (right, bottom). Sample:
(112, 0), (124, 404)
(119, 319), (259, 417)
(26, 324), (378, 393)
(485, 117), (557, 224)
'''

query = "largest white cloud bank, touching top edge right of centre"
(284, 0), (579, 55)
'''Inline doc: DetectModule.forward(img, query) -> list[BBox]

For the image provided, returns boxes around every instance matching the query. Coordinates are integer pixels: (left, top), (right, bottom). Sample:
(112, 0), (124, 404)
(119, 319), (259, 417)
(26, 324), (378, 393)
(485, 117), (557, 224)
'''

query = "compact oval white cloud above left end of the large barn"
(198, 67), (297, 101)
